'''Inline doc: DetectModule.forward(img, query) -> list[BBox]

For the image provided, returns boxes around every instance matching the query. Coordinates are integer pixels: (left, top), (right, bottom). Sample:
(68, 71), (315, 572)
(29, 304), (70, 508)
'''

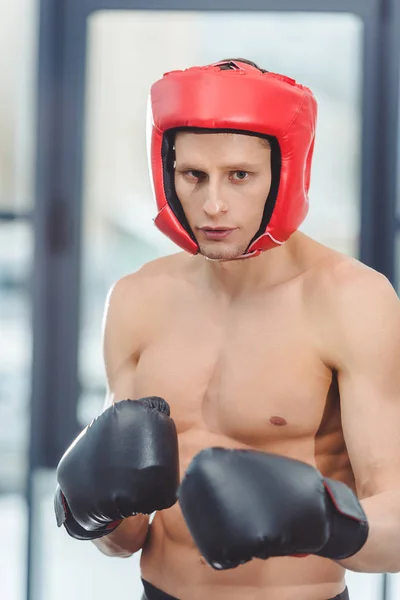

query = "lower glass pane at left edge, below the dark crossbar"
(0, 221), (33, 600)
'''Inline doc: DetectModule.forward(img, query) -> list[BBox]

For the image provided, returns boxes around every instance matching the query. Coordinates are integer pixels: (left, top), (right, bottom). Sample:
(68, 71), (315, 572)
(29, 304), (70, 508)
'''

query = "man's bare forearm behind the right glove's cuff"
(337, 491), (400, 573)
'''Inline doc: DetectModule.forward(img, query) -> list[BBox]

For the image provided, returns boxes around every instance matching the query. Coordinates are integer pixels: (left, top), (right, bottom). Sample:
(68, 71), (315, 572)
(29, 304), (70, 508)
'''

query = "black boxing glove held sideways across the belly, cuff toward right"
(178, 448), (368, 569)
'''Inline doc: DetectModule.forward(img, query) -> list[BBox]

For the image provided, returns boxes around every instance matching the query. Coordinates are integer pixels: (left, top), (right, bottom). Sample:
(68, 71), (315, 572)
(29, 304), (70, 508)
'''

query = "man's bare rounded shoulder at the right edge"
(304, 248), (400, 365)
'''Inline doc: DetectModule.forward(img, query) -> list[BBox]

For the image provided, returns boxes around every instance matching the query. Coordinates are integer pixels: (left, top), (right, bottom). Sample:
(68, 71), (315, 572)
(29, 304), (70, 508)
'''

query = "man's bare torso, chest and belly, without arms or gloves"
(117, 236), (360, 600)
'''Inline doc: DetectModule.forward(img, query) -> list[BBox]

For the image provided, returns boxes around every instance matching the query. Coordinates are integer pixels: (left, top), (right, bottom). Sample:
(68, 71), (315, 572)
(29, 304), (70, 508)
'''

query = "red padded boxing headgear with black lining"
(148, 60), (317, 256)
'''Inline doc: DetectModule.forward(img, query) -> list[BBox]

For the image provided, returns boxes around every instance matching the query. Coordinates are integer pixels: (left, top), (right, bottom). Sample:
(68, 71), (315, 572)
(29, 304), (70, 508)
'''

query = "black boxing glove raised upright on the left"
(54, 397), (179, 540)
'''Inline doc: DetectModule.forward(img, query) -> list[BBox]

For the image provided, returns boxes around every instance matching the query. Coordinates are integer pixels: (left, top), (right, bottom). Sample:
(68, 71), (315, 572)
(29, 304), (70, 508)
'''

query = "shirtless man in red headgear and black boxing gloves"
(55, 60), (400, 600)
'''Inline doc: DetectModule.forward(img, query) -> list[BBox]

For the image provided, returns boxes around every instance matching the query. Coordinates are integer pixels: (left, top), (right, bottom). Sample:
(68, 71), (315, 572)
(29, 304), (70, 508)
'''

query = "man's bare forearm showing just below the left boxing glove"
(93, 515), (149, 558)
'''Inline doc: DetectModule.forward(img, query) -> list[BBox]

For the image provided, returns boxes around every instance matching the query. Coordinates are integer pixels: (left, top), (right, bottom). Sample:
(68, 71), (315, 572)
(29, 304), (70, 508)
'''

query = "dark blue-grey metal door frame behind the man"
(27, 0), (400, 600)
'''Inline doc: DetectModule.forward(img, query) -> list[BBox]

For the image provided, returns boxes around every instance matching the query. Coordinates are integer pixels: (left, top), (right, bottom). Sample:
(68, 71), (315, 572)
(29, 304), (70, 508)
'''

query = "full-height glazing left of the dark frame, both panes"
(0, 0), (37, 600)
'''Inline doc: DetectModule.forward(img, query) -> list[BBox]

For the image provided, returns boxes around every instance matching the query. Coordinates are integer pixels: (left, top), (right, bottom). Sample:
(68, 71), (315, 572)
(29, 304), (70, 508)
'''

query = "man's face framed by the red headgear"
(175, 132), (271, 260)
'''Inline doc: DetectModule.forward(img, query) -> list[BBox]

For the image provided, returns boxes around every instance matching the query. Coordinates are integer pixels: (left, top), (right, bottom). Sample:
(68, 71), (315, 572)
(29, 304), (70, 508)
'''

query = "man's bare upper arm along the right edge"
(332, 278), (400, 497)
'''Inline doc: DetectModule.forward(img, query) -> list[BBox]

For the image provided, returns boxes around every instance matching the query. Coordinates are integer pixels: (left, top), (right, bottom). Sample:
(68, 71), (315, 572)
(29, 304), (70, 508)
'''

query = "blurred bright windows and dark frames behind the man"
(0, 0), (400, 600)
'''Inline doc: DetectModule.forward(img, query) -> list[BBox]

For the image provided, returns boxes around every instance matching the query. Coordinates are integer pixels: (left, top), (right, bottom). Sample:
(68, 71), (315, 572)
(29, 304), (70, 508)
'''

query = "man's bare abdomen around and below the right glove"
(141, 430), (345, 600)
